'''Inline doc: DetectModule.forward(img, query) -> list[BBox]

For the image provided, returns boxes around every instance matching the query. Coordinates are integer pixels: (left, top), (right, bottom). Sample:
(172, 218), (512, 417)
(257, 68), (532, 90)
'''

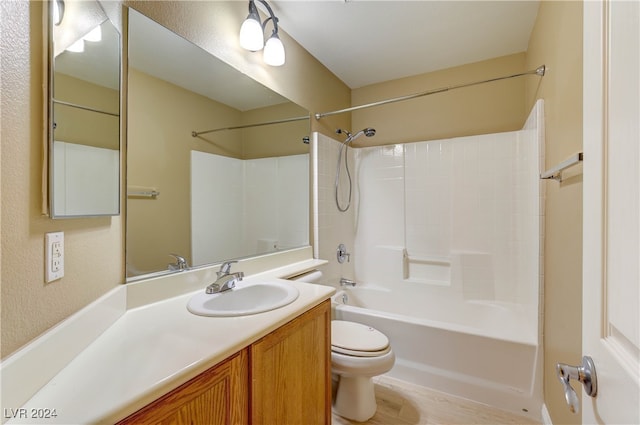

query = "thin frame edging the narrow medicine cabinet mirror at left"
(42, 0), (124, 219)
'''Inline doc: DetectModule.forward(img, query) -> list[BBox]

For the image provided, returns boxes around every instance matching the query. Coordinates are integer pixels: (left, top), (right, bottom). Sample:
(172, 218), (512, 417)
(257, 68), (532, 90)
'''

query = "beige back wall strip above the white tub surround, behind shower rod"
(352, 53), (528, 146)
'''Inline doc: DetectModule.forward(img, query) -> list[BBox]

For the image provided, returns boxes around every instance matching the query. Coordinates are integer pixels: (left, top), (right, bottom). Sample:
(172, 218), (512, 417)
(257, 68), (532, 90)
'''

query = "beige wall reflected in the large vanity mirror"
(126, 69), (309, 276)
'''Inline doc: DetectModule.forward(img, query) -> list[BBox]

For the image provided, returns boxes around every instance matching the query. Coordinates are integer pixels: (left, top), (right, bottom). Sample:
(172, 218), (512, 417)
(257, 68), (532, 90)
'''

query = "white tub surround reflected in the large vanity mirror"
(191, 151), (309, 264)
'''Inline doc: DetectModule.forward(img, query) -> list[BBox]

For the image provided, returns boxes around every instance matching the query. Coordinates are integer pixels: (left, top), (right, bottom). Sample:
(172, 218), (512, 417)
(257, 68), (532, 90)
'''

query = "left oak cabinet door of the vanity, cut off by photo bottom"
(119, 350), (249, 425)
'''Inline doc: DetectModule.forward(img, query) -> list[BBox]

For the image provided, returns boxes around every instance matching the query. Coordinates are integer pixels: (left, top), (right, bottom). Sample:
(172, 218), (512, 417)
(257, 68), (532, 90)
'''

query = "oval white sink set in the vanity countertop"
(187, 281), (299, 317)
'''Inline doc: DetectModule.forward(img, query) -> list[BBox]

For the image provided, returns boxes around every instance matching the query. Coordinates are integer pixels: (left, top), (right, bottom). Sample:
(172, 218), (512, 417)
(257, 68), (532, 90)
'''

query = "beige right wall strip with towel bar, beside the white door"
(527, 1), (583, 424)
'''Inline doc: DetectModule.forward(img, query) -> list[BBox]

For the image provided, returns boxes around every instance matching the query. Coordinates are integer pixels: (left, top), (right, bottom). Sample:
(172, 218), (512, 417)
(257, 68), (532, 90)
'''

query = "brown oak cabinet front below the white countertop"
(118, 300), (331, 425)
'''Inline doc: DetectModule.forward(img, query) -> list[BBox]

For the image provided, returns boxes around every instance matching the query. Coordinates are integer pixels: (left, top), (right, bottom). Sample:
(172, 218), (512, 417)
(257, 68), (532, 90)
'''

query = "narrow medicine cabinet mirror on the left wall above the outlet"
(48, 0), (120, 218)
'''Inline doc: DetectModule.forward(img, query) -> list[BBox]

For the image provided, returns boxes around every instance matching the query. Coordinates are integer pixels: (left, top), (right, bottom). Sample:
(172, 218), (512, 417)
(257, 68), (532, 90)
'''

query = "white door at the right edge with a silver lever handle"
(584, 0), (640, 424)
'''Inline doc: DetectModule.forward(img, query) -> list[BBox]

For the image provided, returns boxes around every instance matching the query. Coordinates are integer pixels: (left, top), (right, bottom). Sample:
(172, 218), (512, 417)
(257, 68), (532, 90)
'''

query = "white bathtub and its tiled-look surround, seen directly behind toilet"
(312, 100), (544, 420)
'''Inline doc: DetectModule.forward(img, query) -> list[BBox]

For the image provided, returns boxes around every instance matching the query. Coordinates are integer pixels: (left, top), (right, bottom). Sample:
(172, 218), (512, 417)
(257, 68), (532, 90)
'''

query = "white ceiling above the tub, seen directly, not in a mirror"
(270, 0), (539, 88)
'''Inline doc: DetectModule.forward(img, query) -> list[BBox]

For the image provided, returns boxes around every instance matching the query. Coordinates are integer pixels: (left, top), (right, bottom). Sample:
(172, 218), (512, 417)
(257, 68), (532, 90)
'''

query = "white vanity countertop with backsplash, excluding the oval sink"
(1, 248), (334, 424)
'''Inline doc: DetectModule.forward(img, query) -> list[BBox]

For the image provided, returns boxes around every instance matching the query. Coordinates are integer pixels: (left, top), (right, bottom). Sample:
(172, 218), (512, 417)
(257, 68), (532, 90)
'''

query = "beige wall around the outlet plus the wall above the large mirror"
(0, 1), (350, 358)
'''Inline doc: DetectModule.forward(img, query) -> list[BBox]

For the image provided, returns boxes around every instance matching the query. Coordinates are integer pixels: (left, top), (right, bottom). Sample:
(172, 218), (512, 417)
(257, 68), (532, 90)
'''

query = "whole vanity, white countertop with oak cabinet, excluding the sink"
(2, 248), (335, 424)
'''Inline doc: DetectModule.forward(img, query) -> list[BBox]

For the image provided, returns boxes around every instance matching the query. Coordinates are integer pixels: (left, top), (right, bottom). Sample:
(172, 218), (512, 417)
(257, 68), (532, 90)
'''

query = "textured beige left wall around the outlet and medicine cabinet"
(0, 1), (124, 357)
